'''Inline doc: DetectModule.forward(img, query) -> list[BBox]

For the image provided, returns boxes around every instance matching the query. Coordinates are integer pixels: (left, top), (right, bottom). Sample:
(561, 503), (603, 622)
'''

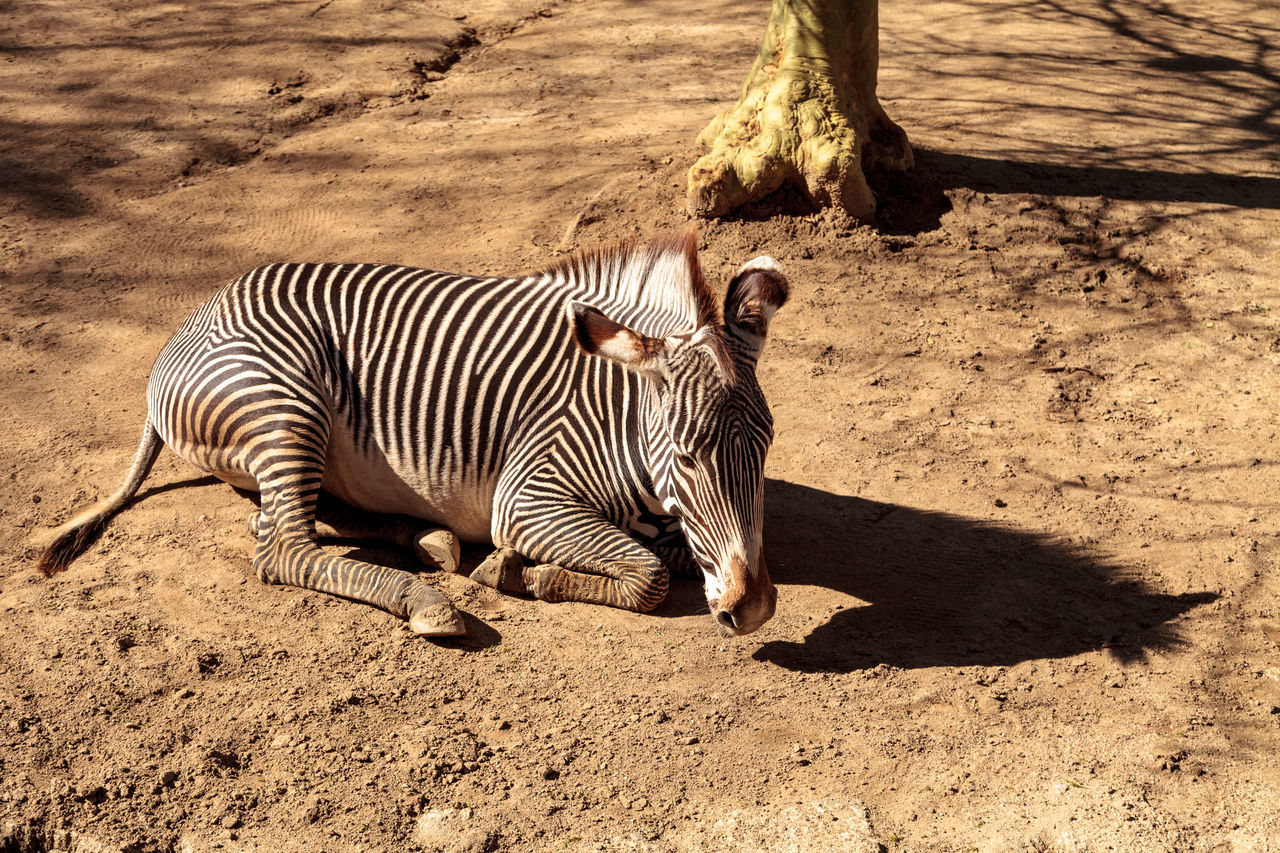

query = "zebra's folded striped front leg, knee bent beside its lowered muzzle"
(472, 507), (669, 612)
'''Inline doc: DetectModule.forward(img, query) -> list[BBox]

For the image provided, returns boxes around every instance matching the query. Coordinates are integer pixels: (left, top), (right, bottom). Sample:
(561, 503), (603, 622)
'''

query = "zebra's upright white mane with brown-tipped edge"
(547, 227), (719, 337)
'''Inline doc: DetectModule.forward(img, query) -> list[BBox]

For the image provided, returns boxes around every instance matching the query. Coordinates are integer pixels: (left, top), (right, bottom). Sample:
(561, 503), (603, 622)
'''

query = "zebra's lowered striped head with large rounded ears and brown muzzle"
(575, 256), (788, 635)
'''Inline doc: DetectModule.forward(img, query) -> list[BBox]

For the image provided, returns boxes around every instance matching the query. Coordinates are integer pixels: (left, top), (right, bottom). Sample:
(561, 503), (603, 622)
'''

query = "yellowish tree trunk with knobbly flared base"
(689, 0), (911, 220)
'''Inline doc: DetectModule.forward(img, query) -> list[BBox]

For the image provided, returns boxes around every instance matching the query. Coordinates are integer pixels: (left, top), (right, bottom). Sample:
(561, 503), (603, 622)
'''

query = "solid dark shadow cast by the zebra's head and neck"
(754, 480), (1217, 672)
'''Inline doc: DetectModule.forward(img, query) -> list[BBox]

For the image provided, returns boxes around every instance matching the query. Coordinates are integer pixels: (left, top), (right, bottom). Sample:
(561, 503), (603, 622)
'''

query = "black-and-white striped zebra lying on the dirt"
(38, 228), (788, 637)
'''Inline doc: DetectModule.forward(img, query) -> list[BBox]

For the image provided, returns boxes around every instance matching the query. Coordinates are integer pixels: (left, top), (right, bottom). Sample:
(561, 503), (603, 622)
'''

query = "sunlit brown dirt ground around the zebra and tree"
(0, 0), (1280, 853)
